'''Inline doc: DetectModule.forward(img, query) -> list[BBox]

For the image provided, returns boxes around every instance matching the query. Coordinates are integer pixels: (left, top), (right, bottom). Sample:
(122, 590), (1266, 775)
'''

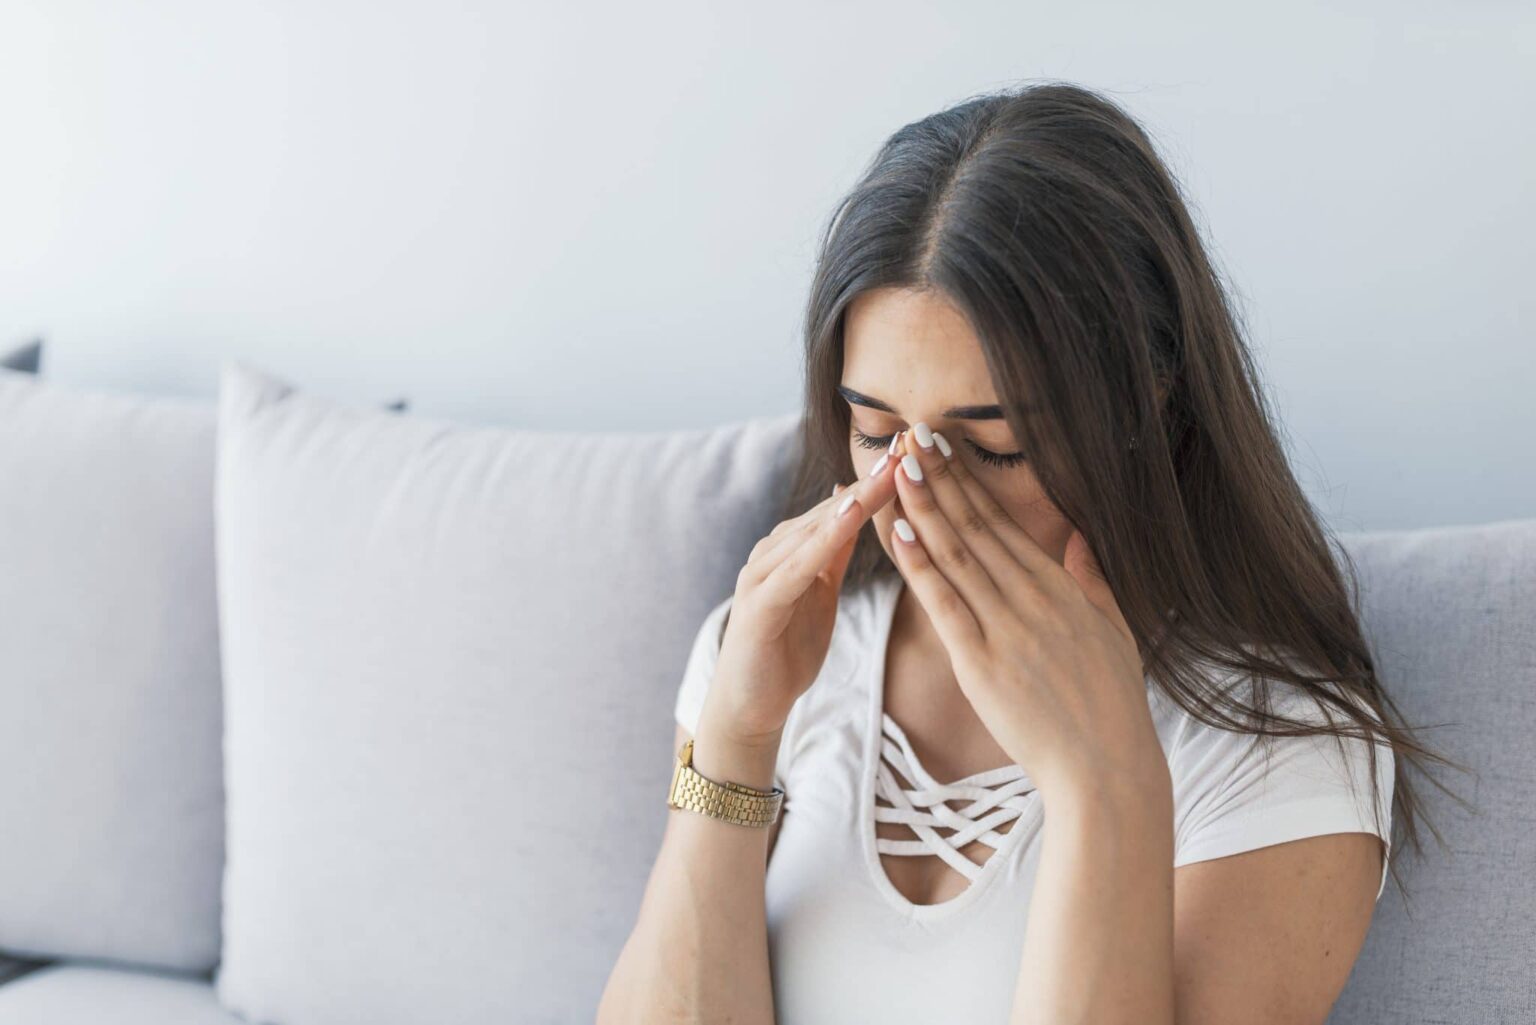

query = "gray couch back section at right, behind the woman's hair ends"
(1330, 519), (1536, 1025)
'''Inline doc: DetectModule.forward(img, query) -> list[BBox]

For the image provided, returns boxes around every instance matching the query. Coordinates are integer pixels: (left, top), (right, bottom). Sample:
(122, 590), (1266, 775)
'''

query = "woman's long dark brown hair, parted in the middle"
(785, 81), (1464, 894)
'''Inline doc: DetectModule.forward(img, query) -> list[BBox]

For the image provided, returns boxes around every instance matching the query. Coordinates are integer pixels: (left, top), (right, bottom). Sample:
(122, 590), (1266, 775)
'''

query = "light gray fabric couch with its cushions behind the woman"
(0, 363), (1536, 1025)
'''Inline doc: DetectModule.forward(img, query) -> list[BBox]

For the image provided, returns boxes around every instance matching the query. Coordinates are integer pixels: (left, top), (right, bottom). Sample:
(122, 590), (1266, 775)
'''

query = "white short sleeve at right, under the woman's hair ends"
(1169, 684), (1395, 901)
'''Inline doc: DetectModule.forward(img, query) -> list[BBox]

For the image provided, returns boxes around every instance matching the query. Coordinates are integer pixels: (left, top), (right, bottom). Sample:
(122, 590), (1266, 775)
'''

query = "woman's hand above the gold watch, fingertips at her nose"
(703, 433), (897, 744)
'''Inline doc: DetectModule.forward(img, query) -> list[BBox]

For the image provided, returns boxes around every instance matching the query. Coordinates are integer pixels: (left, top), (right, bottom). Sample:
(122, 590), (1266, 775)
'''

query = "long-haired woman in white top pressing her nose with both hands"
(599, 83), (1444, 1025)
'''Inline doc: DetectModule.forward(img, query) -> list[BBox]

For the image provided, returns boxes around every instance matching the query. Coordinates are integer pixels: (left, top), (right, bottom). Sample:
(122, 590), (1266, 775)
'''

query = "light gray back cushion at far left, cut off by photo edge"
(0, 373), (224, 971)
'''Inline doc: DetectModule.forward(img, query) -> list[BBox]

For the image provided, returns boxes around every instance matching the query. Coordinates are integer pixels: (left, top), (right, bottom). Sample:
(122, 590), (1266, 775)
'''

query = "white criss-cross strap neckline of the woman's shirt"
(860, 576), (1041, 919)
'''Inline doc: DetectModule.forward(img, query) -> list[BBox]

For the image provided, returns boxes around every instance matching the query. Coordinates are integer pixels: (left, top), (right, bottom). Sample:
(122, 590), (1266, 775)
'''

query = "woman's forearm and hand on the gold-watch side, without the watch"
(598, 457), (895, 1025)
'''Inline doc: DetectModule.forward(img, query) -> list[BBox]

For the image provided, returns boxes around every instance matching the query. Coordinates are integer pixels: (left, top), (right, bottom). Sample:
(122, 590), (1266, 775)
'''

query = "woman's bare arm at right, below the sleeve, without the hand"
(1011, 773), (1384, 1025)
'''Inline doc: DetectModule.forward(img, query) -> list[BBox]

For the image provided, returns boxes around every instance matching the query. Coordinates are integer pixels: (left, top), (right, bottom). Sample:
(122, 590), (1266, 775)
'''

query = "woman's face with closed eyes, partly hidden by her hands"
(840, 289), (1072, 562)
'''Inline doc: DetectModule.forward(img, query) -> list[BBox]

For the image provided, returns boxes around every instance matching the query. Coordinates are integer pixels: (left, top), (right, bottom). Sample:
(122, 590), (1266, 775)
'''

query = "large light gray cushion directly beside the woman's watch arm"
(217, 361), (797, 1025)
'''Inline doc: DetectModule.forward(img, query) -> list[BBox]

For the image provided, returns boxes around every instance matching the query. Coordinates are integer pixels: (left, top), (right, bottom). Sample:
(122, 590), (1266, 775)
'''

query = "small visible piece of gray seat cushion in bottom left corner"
(0, 964), (238, 1025)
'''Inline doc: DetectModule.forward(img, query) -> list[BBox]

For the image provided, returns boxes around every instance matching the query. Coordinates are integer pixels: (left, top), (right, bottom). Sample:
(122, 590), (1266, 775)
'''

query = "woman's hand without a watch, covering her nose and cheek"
(885, 432), (1169, 794)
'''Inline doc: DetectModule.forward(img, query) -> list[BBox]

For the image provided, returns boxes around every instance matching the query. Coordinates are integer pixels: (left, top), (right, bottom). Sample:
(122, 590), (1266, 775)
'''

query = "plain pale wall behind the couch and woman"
(0, 0), (1536, 529)
